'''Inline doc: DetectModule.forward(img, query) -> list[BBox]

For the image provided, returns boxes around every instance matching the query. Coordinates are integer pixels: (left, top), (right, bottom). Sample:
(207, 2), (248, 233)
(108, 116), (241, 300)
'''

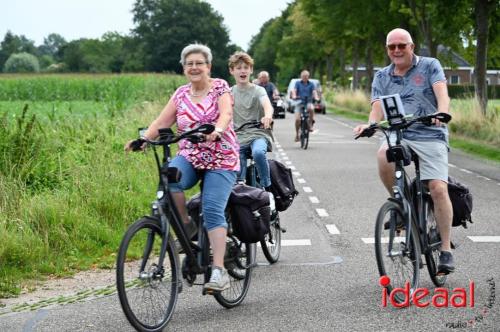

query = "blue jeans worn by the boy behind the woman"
(238, 138), (271, 187)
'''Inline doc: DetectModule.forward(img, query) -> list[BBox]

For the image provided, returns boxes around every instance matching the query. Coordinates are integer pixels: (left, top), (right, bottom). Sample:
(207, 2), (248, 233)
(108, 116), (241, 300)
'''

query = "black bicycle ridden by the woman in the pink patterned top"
(116, 124), (255, 332)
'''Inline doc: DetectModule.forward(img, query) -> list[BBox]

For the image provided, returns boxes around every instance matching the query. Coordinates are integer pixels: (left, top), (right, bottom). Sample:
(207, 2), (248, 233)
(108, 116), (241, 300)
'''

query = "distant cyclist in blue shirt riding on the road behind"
(291, 70), (319, 142)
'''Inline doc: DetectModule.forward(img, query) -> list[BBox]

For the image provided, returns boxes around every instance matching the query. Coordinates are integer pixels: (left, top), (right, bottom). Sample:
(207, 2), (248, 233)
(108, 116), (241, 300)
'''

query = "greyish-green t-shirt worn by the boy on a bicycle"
(231, 84), (273, 150)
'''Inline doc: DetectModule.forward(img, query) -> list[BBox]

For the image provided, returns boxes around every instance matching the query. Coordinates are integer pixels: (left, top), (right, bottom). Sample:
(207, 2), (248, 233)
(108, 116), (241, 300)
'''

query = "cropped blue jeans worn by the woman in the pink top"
(169, 156), (236, 231)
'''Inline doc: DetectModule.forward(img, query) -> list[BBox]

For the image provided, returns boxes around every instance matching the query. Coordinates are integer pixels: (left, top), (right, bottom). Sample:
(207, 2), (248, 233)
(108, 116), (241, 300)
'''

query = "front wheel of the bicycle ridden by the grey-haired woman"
(116, 217), (179, 331)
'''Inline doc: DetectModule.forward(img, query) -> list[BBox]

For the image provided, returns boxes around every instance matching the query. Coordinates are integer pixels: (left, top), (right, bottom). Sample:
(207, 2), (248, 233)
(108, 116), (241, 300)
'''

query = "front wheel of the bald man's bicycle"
(375, 201), (420, 303)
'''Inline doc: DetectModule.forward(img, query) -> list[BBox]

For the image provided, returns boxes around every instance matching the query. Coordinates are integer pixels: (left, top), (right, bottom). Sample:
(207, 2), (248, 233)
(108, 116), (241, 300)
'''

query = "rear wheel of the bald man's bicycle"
(424, 198), (447, 287)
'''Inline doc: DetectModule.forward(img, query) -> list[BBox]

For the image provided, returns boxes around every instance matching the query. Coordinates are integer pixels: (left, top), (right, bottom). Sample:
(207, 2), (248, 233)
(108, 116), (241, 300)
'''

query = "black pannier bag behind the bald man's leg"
(448, 176), (472, 228)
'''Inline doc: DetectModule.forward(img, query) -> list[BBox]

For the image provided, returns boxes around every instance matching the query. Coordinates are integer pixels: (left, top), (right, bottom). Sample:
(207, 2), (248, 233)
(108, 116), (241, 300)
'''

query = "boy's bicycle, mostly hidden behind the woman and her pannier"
(235, 121), (286, 264)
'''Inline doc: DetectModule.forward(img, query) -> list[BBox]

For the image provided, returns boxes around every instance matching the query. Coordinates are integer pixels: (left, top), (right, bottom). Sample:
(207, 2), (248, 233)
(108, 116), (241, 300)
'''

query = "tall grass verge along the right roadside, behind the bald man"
(325, 90), (500, 162)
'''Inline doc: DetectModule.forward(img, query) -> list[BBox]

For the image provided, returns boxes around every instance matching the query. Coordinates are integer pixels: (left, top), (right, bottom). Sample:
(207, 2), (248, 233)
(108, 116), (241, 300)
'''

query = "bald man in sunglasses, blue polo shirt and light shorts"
(354, 28), (455, 274)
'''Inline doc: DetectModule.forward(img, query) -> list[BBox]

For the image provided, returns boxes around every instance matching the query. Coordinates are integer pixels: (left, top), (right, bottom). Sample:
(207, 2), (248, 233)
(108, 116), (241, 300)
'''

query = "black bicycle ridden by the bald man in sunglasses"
(355, 113), (451, 303)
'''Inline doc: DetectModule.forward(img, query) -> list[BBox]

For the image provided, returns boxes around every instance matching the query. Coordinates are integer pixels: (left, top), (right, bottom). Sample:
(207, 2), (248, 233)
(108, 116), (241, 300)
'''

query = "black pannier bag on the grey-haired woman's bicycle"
(228, 184), (271, 243)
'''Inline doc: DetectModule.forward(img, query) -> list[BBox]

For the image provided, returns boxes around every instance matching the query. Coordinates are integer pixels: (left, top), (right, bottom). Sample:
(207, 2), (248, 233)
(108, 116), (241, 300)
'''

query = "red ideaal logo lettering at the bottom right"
(379, 276), (474, 308)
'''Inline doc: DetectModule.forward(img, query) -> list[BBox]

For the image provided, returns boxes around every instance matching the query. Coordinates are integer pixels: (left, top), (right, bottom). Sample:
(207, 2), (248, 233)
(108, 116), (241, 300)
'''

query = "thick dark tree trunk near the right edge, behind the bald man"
(474, 0), (490, 115)
